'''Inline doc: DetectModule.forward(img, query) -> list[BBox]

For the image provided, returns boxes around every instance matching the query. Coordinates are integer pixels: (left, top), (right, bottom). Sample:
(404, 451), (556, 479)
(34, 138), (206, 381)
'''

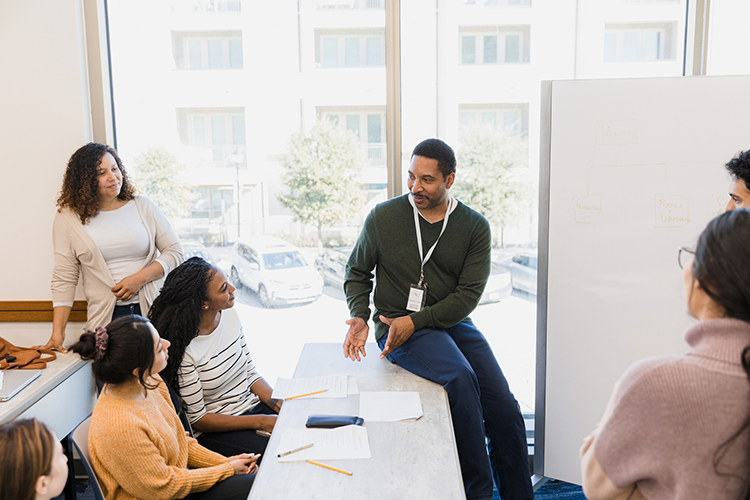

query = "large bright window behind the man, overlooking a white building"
(107, 0), (750, 438)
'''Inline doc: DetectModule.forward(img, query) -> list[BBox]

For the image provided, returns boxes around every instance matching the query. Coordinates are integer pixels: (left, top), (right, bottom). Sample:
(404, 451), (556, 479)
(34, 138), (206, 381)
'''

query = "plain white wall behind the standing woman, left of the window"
(0, 0), (92, 337)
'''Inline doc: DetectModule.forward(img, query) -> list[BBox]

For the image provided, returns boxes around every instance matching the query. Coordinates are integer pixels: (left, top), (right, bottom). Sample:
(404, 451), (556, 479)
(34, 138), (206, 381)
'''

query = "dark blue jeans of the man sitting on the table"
(378, 322), (534, 500)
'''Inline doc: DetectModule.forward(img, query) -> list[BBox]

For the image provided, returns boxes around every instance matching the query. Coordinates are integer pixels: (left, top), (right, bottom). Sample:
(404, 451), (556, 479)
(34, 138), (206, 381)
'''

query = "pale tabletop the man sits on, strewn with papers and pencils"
(249, 344), (465, 500)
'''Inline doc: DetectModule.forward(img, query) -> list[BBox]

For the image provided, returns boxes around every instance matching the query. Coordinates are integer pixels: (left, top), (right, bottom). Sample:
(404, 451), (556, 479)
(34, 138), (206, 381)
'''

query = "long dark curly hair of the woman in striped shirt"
(148, 257), (216, 392)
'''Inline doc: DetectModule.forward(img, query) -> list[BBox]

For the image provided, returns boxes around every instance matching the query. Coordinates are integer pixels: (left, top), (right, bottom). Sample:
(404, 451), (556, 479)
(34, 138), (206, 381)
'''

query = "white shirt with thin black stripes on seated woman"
(178, 309), (261, 434)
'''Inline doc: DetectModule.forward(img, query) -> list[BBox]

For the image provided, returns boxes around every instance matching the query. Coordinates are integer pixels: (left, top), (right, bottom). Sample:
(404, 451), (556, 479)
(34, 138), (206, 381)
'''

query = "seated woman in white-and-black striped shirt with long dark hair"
(149, 257), (282, 455)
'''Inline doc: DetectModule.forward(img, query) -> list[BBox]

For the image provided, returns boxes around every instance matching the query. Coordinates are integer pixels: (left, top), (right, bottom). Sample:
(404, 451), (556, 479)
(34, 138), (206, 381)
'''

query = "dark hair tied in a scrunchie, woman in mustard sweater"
(70, 316), (154, 389)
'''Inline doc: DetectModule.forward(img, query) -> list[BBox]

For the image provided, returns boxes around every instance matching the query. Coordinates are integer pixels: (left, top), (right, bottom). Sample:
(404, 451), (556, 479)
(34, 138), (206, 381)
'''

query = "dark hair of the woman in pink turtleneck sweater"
(692, 209), (750, 322)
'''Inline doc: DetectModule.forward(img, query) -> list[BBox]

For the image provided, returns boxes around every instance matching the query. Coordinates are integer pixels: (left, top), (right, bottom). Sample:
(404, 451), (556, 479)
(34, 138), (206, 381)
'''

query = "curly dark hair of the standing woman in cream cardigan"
(57, 142), (135, 225)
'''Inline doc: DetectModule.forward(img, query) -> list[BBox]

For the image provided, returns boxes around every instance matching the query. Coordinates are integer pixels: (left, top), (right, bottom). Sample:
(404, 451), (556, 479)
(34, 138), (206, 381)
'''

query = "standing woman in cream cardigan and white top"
(40, 142), (184, 352)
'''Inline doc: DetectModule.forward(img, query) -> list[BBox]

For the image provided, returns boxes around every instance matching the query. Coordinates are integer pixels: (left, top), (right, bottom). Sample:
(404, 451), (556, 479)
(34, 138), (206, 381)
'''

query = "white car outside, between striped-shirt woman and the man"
(230, 236), (323, 307)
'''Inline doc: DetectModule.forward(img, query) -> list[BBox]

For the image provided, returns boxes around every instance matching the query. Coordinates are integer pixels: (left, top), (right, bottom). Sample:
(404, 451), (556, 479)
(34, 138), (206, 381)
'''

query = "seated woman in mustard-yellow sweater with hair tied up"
(71, 316), (258, 500)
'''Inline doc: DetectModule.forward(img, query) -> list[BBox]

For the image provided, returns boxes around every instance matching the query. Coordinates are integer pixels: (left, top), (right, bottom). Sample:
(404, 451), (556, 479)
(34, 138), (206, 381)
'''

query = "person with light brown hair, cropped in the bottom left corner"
(0, 419), (68, 500)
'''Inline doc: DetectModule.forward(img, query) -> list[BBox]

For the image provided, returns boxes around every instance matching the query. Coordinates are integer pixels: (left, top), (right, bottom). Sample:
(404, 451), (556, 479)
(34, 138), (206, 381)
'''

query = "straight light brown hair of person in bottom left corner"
(0, 419), (59, 500)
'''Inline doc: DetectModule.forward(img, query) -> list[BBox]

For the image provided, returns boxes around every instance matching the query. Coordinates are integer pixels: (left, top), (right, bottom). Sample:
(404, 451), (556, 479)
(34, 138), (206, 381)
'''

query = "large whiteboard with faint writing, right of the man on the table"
(537, 77), (750, 484)
